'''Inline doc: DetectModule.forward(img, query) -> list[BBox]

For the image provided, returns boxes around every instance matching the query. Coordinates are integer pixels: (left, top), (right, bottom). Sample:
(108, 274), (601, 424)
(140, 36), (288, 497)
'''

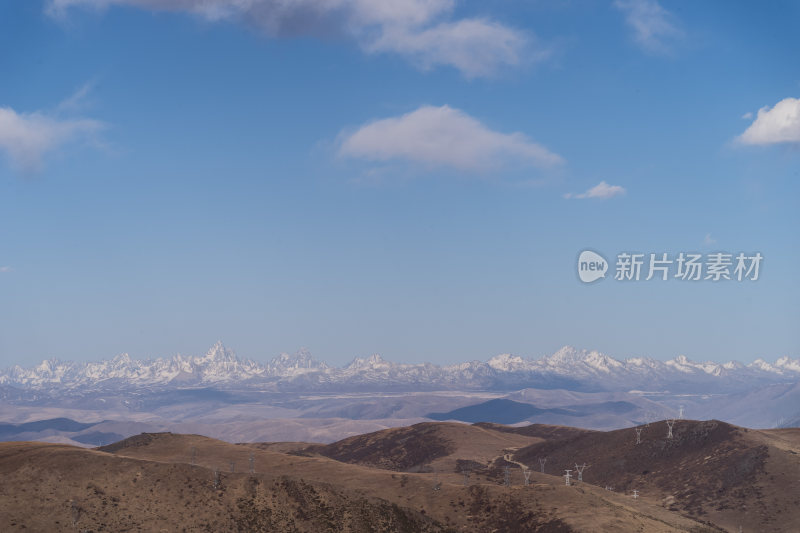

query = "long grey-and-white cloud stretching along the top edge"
(47, 0), (536, 77)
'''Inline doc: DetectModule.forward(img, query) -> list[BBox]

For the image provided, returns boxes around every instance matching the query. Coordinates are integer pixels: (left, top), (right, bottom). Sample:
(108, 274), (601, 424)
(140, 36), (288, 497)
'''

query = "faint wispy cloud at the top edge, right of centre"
(614, 0), (683, 53)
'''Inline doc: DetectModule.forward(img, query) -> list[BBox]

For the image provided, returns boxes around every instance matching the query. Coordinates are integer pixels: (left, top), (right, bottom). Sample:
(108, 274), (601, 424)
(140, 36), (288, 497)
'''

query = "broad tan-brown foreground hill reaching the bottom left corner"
(0, 426), (717, 533)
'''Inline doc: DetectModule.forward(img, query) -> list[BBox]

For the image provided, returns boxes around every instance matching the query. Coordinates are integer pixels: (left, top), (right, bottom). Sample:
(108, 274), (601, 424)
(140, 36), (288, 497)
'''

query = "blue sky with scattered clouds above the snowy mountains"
(0, 0), (800, 365)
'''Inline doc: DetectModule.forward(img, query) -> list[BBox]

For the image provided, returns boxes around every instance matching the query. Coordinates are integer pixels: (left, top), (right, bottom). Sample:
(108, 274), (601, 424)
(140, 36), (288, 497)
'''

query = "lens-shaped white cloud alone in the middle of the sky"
(339, 105), (563, 175)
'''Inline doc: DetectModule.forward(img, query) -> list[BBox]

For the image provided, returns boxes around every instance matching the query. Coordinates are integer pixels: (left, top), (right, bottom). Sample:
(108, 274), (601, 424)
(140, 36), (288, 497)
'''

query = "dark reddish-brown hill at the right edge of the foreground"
(513, 420), (800, 532)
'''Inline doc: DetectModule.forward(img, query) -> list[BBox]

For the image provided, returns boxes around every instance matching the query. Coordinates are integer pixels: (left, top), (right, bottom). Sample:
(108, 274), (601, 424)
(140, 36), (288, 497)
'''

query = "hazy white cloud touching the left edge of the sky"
(0, 107), (102, 173)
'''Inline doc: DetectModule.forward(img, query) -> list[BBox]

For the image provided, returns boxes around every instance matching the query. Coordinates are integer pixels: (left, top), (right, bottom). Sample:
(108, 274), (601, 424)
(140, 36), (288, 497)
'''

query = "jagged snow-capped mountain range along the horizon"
(0, 342), (800, 393)
